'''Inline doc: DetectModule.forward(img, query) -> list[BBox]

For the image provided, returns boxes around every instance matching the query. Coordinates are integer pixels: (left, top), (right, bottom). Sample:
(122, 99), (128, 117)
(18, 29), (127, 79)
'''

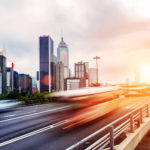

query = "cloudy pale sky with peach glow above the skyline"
(0, 0), (150, 83)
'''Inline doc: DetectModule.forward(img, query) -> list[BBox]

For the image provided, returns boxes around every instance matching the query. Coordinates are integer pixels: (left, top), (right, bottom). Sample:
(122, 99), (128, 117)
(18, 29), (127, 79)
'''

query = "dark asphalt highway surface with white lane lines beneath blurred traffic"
(0, 97), (150, 150)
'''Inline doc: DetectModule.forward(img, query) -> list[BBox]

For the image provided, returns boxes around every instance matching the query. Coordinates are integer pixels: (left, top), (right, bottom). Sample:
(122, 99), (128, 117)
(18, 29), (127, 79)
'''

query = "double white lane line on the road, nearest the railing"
(0, 120), (69, 147)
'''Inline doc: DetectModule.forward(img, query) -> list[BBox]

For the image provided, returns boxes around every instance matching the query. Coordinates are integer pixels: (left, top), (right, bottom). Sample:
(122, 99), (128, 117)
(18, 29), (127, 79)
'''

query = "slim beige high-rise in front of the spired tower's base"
(56, 62), (64, 91)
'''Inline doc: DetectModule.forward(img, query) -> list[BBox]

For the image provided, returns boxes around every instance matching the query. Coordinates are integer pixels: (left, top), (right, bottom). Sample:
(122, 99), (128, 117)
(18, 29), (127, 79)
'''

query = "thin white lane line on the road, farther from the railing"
(0, 106), (70, 123)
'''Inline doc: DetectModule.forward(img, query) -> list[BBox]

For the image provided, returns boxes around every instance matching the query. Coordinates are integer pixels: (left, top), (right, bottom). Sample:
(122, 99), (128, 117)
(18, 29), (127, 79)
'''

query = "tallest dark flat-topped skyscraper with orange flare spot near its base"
(39, 36), (55, 92)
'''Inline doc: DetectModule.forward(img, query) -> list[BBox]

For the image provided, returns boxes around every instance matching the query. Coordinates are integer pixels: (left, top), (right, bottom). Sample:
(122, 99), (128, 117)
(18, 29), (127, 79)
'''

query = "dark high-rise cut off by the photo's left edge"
(0, 52), (6, 94)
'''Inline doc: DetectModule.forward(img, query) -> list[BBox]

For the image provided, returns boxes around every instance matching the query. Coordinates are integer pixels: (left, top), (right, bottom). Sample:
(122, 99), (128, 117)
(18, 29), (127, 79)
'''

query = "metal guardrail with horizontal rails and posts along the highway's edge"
(67, 103), (150, 150)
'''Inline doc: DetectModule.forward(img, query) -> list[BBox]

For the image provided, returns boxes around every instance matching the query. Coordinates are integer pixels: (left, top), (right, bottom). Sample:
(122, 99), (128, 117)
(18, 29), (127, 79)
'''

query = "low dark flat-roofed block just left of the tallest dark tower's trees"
(18, 74), (32, 94)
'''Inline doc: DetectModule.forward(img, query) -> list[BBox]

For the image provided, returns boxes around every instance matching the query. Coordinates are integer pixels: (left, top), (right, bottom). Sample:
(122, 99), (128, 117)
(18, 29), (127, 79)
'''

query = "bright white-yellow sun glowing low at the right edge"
(140, 64), (150, 83)
